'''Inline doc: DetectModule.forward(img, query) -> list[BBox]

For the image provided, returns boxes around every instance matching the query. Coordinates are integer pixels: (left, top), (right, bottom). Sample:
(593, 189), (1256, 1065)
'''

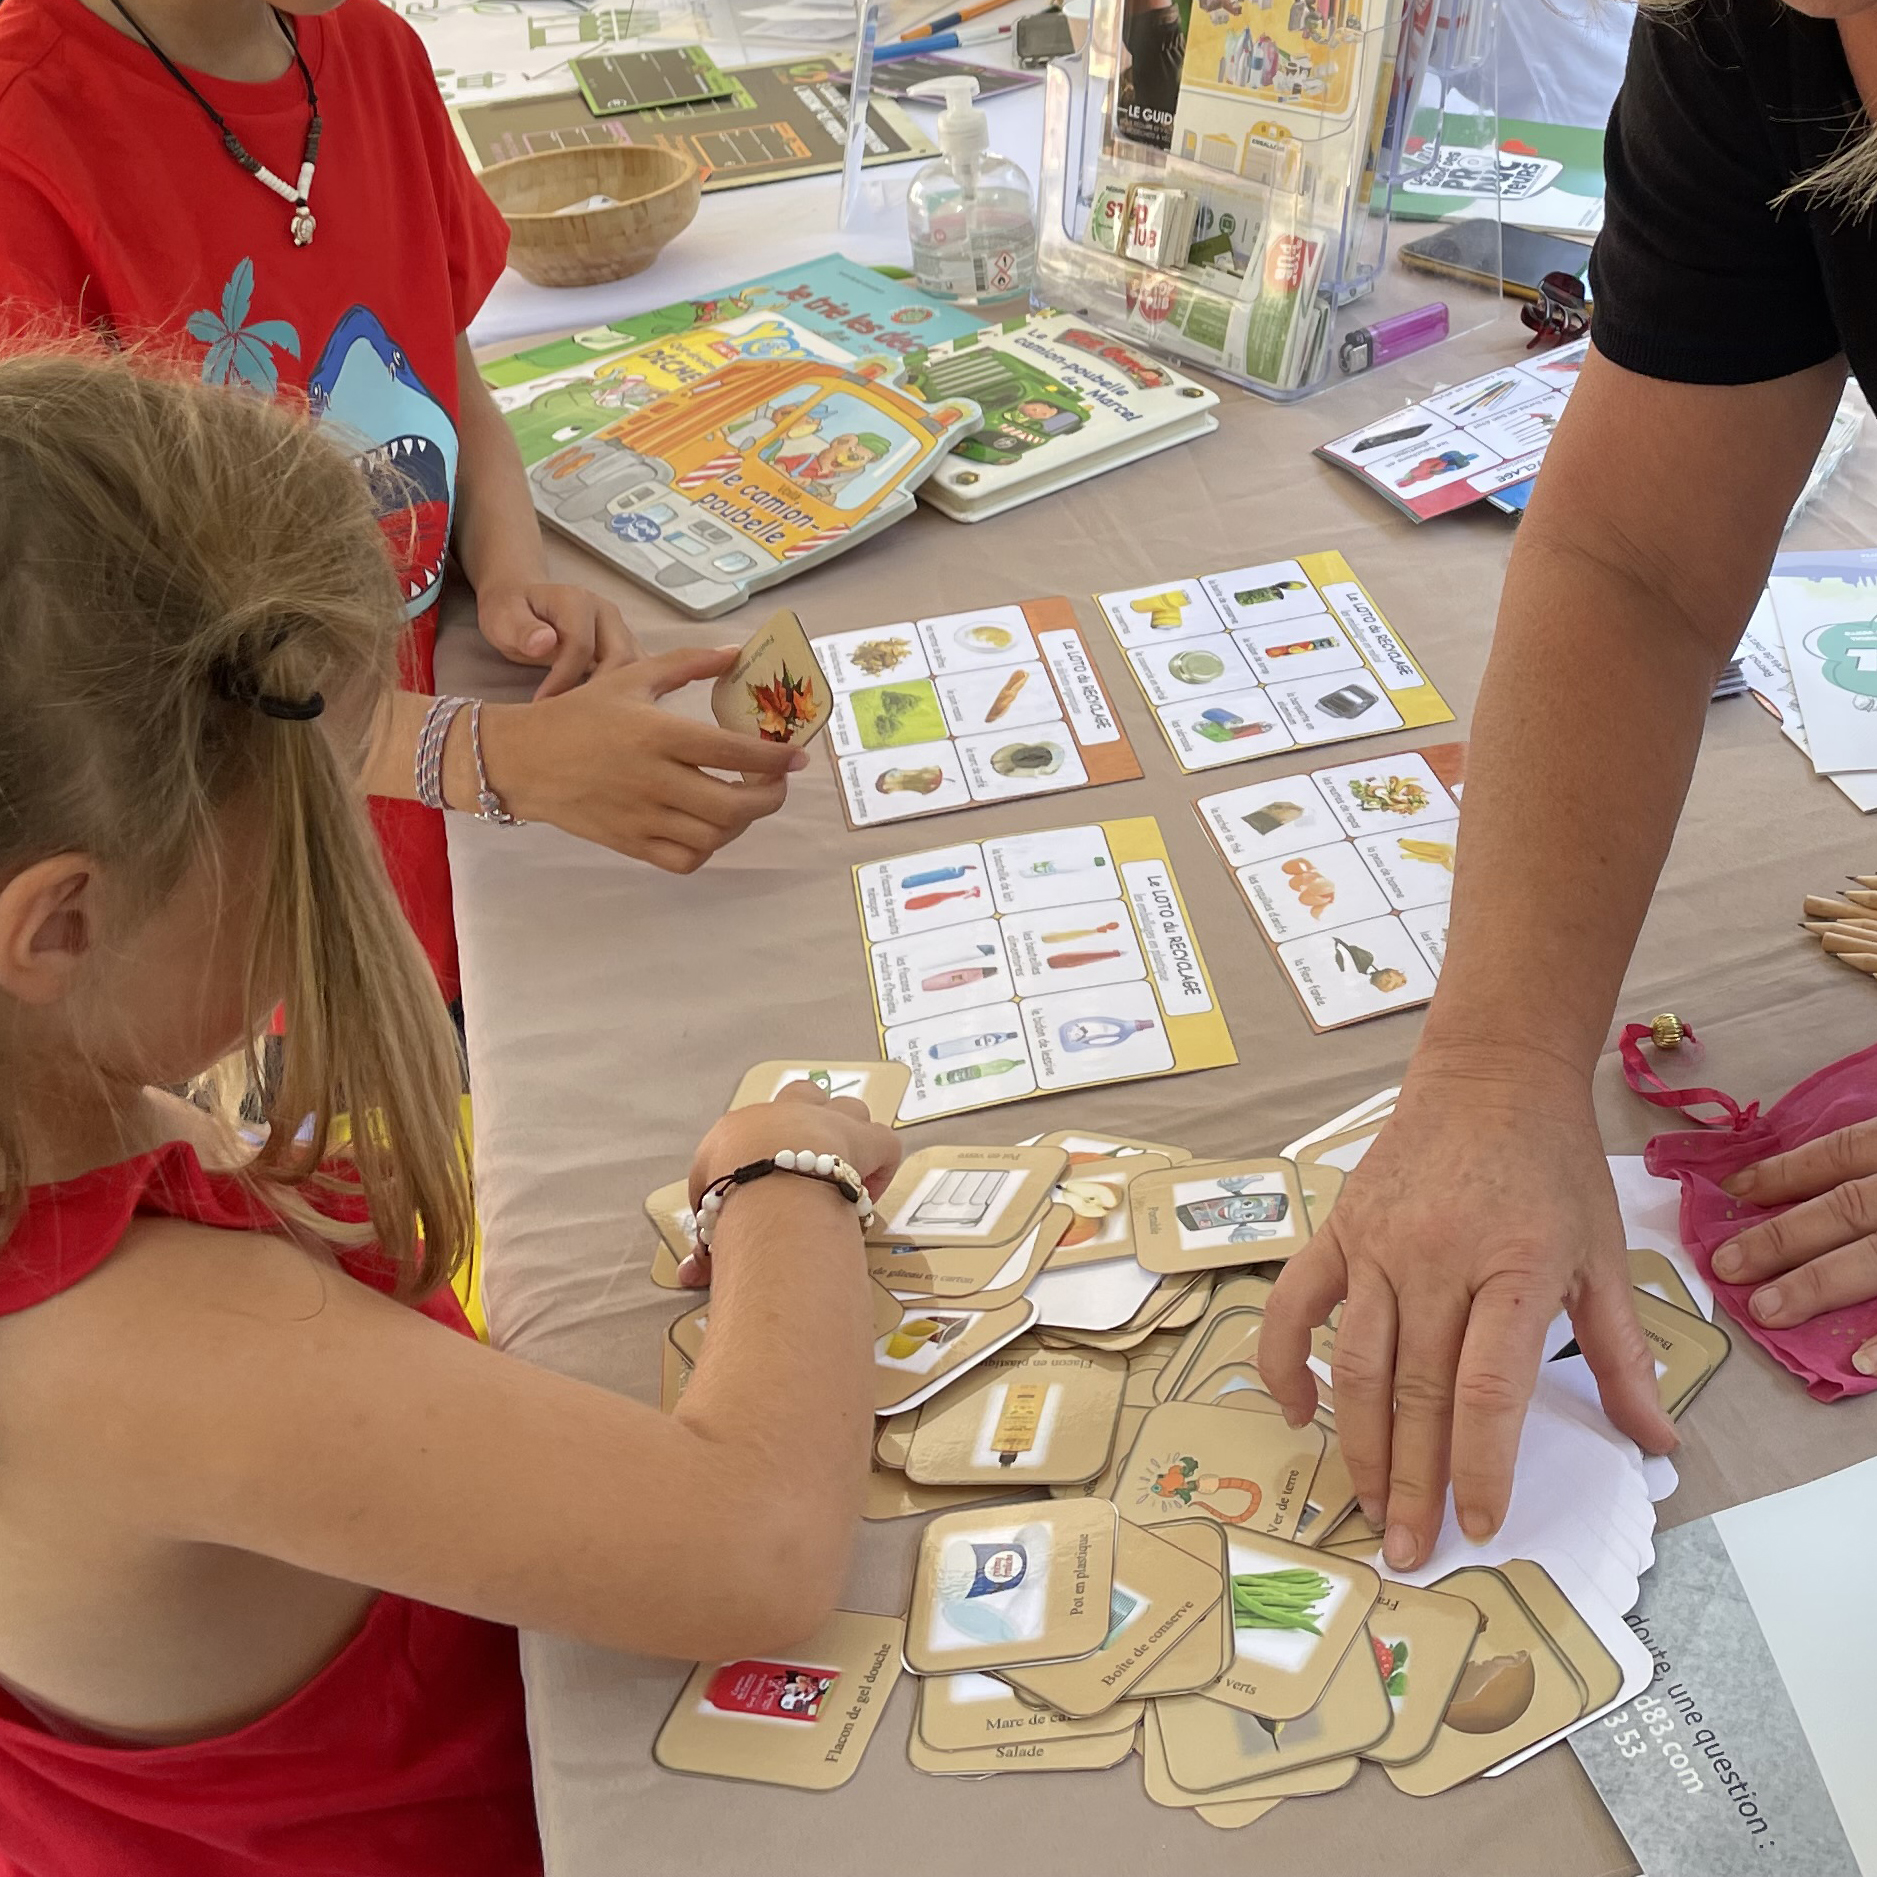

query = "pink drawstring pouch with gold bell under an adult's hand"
(1622, 1023), (1877, 1402)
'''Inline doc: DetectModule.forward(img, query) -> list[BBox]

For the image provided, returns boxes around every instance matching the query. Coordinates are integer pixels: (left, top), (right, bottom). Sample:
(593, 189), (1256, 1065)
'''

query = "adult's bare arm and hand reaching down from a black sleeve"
(1259, 351), (1845, 1569)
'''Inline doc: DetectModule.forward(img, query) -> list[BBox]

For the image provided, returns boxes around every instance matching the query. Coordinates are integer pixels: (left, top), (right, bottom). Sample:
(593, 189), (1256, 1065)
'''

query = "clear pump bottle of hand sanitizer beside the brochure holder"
(907, 73), (1036, 319)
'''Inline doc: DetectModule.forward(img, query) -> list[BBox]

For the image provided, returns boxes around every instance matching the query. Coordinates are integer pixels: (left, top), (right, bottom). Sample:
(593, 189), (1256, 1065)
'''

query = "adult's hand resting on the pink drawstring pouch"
(1714, 1121), (1877, 1376)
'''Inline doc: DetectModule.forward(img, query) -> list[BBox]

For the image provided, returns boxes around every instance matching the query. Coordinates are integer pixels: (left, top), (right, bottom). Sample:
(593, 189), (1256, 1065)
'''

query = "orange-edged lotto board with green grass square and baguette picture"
(815, 599), (1141, 828)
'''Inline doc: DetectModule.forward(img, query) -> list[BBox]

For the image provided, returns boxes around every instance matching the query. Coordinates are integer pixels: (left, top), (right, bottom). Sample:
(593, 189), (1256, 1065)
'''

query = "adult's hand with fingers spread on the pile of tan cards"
(1258, 1076), (1676, 1571)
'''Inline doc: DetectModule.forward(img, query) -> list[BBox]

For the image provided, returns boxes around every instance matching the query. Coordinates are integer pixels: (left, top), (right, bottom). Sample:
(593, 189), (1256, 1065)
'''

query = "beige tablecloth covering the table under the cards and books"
(437, 281), (1877, 1877)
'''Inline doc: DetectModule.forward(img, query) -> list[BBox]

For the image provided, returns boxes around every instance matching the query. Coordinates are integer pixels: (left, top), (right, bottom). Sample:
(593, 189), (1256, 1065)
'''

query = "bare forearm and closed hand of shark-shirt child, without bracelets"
(456, 334), (638, 698)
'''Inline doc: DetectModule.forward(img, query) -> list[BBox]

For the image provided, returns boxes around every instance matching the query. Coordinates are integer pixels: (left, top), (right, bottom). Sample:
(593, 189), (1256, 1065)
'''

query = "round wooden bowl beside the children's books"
(482, 143), (704, 287)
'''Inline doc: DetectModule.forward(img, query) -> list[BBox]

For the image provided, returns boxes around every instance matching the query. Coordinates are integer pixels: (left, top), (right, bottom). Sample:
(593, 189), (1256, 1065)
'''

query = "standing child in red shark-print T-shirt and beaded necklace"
(0, 0), (800, 997)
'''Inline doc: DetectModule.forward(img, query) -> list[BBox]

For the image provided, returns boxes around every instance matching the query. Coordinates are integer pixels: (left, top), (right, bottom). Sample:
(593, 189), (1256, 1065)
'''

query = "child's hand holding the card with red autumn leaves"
(482, 648), (809, 873)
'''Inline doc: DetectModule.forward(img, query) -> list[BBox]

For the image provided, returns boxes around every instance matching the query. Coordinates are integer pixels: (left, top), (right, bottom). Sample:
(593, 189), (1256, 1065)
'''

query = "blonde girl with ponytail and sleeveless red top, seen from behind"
(0, 354), (897, 1877)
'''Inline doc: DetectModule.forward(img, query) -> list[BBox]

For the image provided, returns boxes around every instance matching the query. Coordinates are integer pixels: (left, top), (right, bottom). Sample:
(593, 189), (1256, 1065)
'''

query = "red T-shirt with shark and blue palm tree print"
(0, 0), (509, 997)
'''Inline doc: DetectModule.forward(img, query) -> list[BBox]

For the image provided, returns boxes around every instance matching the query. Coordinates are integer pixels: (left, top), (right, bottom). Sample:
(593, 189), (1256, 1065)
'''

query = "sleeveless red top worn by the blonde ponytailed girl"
(0, 1141), (541, 1877)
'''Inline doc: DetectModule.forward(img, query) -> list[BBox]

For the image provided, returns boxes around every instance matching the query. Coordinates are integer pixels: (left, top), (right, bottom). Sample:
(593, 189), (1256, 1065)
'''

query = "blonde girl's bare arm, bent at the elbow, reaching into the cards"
(0, 1091), (899, 1659)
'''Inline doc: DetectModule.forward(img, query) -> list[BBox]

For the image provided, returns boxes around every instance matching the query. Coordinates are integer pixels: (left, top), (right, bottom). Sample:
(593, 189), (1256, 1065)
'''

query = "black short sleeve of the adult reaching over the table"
(1592, 0), (1877, 398)
